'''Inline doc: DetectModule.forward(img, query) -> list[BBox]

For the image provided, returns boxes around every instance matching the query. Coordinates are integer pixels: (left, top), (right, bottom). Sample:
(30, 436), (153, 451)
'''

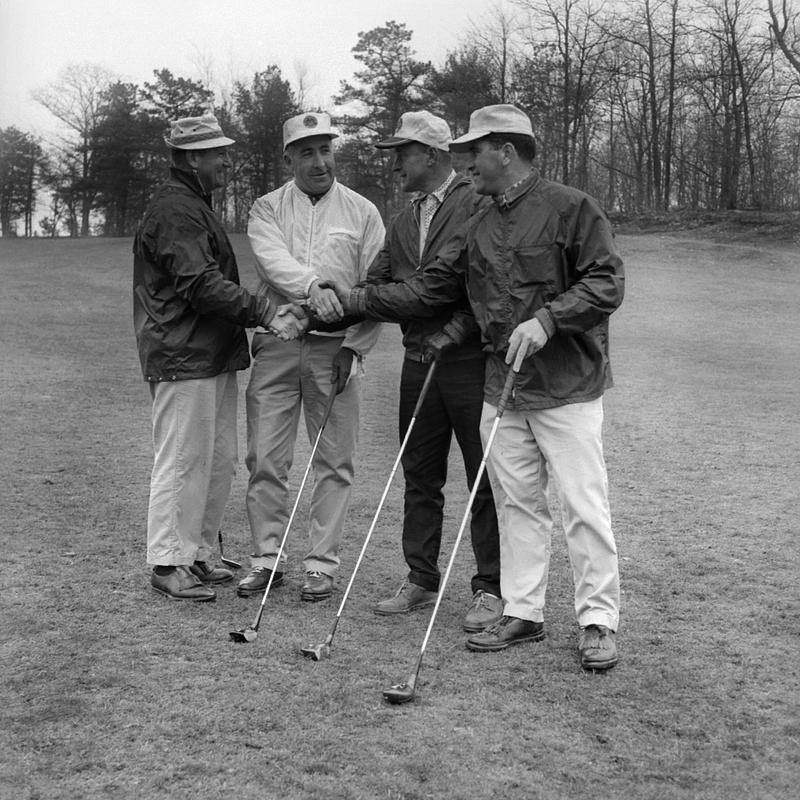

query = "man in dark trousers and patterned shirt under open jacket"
(367, 111), (503, 633)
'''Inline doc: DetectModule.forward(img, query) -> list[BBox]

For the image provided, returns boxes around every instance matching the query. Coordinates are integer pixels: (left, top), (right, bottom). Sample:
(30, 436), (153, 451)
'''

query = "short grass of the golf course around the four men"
(0, 233), (800, 800)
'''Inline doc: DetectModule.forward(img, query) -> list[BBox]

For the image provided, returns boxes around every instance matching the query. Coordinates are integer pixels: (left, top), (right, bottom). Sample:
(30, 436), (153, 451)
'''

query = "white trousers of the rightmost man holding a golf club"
(481, 398), (619, 630)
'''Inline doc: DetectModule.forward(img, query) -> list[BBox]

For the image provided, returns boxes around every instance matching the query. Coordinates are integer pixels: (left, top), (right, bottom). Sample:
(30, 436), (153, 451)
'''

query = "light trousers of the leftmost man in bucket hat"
(147, 372), (238, 566)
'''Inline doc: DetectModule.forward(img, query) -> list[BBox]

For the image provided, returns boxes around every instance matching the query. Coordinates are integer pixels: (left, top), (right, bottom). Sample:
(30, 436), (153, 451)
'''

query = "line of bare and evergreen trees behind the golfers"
(0, 0), (800, 236)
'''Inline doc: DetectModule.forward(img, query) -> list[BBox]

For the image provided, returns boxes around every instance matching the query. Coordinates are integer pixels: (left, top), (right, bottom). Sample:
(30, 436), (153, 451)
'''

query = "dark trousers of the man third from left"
(400, 353), (500, 597)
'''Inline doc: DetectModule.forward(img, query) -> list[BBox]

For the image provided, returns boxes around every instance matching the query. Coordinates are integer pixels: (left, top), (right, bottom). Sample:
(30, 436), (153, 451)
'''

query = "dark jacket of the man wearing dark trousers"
(365, 175), (484, 361)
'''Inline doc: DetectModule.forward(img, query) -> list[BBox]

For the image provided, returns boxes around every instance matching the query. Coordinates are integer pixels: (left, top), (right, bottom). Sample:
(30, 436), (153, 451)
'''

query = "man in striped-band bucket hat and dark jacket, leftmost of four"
(133, 114), (275, 601)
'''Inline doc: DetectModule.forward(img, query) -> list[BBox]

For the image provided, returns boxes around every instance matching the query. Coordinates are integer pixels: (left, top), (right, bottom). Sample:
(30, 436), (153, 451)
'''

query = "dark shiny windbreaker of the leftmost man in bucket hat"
(133, 168), (269, 381)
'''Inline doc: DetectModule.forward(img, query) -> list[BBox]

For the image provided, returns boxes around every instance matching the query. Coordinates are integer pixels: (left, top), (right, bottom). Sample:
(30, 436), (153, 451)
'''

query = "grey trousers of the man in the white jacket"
(246, 333), (360, 576)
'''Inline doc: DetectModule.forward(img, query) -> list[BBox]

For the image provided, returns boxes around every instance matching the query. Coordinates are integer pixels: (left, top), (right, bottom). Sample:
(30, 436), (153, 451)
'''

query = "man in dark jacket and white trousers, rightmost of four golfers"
(340, 104), (624, 670)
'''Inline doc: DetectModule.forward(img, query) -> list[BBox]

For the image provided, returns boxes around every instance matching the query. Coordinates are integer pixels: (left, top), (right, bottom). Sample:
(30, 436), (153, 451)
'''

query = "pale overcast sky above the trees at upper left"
(0, 0), (492, 138)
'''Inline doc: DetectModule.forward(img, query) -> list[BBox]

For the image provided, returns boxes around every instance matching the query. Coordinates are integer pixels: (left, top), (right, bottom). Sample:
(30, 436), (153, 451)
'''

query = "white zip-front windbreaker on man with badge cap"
(247, 180), (384, 356)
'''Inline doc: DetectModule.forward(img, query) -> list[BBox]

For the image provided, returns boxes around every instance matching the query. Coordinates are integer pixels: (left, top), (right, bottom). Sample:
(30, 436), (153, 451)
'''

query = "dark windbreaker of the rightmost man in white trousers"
(368, 171), (625, 410)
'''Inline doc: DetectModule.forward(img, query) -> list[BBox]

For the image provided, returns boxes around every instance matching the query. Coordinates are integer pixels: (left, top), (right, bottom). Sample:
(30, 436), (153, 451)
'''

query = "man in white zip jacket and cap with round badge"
(238, 113), (384, 601)
